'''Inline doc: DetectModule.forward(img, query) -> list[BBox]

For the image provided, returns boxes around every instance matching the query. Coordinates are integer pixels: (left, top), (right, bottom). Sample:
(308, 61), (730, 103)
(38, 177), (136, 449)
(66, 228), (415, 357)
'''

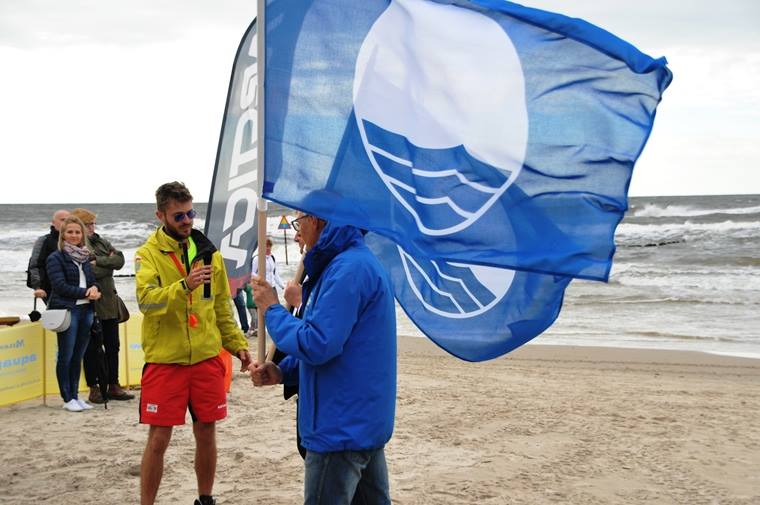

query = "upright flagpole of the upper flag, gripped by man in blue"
(256, 0), (267, 363)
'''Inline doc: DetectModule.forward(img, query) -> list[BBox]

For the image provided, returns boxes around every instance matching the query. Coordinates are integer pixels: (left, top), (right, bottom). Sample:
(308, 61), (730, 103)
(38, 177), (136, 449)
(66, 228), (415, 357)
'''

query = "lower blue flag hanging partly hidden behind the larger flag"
(365, 232), (570, 361)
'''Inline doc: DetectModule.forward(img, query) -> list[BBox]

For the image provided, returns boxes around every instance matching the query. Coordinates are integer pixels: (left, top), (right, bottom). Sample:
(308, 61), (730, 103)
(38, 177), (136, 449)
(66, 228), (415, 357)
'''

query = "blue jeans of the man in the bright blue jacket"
(304, 447), (391, 505)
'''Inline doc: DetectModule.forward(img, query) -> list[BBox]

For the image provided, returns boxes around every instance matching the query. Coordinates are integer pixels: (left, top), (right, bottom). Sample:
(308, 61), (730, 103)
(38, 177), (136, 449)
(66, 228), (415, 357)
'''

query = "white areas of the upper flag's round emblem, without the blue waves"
(353, 0), (528, 235)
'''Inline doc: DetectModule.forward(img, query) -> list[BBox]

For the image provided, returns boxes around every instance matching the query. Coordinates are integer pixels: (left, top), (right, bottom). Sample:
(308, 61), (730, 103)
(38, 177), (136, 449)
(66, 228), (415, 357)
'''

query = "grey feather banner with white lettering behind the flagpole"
(204, 20), (259, 294)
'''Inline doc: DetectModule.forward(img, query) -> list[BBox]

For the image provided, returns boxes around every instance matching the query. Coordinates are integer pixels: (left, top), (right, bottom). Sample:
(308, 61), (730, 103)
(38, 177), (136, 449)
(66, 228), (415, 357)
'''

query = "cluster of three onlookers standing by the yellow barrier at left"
(27, 208), (134, 412)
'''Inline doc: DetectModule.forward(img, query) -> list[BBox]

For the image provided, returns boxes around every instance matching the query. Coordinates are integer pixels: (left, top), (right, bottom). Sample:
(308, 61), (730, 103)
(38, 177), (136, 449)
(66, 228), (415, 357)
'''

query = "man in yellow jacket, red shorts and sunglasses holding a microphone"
(135, 182), (251, 505)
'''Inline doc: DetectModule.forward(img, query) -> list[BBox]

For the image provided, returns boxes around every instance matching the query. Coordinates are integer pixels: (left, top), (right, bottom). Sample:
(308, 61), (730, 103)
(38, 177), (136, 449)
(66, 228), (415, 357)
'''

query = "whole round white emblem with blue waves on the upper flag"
(353, 0), (528, 236)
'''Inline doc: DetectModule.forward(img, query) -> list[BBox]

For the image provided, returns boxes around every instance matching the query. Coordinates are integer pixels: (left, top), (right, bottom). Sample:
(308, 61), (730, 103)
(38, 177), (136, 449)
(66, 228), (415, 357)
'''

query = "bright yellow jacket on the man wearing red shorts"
(135, 227), (248, 365)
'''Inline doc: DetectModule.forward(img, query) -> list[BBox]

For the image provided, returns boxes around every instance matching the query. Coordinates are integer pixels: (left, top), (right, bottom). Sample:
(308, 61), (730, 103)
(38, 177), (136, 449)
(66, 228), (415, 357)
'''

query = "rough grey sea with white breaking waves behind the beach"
(0, 195), (760, 358)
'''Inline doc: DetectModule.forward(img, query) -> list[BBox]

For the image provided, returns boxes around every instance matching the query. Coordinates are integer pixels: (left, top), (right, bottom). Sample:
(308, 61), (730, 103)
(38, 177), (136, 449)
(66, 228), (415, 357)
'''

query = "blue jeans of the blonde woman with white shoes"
(55, 303), (93, 402)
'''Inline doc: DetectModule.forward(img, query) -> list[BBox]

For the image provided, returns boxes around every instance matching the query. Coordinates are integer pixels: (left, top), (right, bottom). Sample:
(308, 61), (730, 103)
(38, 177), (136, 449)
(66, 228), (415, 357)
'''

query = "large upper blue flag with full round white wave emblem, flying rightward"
(264, 0), (671, 280)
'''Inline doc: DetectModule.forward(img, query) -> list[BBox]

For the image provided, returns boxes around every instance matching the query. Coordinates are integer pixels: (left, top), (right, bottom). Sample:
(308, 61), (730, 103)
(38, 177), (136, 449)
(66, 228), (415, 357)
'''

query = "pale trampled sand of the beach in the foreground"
(0, 337), (760, 505)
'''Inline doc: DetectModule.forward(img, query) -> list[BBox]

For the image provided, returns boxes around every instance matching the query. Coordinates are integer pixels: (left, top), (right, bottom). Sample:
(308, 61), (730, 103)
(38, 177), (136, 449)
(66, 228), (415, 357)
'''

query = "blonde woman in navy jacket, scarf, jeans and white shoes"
(46, 216), (100, 412)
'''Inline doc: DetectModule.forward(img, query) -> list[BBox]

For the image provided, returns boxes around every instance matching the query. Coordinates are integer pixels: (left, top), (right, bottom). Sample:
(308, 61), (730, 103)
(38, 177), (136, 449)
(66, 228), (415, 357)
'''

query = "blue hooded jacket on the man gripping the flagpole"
(266, 224), (396, 453)
